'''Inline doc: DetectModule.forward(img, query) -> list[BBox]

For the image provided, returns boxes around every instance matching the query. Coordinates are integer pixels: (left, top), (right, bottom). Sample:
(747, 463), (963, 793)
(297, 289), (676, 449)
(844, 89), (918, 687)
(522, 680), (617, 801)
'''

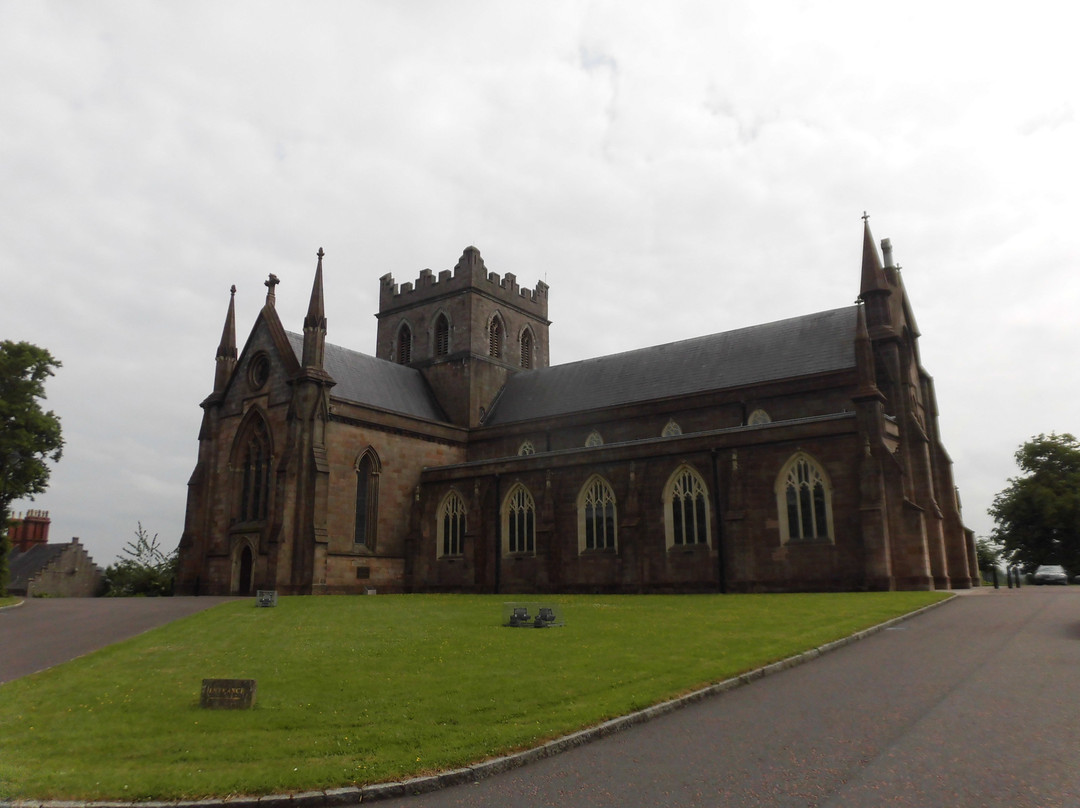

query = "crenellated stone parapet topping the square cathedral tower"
(379, 246), (548, 320)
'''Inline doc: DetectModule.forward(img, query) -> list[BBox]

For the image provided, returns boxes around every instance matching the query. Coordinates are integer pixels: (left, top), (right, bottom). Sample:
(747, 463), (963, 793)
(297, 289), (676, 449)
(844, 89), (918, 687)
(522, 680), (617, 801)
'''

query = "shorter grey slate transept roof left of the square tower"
(286, 332), (446, 421)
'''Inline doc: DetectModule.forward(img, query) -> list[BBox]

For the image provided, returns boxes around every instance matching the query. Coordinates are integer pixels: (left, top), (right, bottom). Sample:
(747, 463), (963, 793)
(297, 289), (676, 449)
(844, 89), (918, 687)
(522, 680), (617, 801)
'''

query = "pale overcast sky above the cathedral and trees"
(0, 0), (1080, 566)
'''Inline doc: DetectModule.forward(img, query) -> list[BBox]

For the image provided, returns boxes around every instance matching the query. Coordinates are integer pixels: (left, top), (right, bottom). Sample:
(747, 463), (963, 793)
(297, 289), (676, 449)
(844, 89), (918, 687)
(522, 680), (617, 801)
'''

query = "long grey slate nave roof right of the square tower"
(485, 306), (858, 425)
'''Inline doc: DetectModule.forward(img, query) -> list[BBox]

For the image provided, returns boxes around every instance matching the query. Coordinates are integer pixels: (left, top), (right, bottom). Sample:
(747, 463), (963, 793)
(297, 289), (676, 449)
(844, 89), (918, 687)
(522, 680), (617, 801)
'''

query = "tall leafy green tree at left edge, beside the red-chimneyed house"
(0, 340), (64, 594)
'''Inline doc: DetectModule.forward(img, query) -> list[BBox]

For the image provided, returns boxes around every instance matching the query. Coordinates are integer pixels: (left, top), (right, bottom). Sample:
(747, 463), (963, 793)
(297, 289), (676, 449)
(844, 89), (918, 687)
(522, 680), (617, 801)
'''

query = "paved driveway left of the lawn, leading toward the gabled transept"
(0, 597), (232, 683)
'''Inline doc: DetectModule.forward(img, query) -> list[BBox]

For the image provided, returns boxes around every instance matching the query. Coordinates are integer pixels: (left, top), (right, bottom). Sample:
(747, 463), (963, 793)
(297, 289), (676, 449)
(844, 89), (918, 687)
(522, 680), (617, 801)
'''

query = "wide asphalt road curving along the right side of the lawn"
(380, 587), (1080, 808)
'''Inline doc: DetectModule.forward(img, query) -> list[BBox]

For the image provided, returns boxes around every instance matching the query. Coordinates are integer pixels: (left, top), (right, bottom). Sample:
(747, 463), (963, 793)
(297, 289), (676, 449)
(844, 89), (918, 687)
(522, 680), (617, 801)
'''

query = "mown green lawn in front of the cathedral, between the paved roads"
(0, 592), (943, 799)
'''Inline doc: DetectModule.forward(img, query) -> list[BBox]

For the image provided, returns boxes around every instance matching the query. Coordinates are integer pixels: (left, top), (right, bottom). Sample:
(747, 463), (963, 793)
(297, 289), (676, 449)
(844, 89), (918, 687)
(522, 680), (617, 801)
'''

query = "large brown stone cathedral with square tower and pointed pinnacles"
(176, 220), (977, 594)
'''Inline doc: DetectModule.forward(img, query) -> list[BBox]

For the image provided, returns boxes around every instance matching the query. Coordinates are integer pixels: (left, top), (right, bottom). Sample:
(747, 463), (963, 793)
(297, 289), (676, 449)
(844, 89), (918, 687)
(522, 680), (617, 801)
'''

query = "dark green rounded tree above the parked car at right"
(989, 432), (1080, 573)
